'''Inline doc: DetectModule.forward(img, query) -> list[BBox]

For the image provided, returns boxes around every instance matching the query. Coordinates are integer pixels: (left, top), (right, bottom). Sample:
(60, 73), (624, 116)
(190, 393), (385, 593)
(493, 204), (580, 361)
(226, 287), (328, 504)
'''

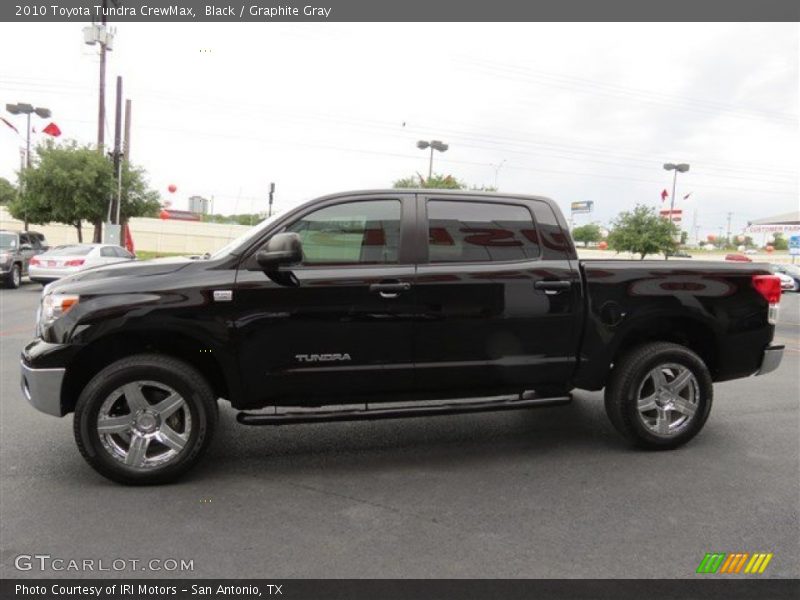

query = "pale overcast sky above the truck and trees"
(0, 23), (800, 236)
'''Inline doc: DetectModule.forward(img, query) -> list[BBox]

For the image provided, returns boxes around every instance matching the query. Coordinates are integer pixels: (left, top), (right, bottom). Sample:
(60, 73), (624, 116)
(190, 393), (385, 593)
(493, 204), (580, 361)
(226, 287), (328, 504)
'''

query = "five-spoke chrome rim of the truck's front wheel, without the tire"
(97, 381), (192, 469)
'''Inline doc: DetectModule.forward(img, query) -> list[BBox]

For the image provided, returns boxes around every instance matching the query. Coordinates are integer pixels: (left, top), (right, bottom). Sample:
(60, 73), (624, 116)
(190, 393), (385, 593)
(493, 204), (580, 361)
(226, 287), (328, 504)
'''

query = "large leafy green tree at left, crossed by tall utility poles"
(9, 142), (159, 242)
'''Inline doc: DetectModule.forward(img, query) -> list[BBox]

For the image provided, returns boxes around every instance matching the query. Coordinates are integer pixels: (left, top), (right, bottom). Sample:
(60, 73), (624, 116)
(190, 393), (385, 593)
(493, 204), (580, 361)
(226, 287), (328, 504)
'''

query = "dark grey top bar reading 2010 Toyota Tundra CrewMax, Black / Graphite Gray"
(0, 0), (800, 23)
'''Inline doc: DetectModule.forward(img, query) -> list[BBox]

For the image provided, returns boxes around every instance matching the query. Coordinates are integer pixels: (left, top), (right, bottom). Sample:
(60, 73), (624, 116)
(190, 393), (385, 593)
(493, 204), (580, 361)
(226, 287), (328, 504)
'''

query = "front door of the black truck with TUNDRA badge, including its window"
(235, 193), (417, 404)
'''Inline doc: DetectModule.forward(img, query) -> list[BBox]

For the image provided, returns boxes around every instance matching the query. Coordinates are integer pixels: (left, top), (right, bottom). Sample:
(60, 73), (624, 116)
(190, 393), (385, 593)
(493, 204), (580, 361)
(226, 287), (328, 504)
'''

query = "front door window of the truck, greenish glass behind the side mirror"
(288, 200), (400, 265)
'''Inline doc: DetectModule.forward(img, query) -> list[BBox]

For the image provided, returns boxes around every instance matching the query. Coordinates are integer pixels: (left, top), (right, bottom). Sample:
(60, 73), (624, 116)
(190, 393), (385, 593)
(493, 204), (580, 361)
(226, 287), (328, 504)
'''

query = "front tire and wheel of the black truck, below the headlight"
(73, 354), (218, 485)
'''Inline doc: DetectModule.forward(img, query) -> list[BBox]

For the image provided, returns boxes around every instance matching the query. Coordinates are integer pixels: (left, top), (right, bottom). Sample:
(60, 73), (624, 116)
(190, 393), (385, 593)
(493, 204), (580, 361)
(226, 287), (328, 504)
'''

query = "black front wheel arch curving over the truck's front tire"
(61, 331), (231, 414)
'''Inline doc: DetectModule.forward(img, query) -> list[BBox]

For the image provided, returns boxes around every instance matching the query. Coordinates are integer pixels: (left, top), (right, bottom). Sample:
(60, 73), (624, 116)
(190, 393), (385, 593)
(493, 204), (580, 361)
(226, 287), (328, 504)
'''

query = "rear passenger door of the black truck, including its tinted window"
(414, 194), (580, 392)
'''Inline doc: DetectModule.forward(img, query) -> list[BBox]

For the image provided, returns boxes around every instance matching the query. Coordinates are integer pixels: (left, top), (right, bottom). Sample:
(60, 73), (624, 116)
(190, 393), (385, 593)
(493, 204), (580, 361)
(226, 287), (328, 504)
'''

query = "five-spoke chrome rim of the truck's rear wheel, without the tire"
(636, 363), (700, 437)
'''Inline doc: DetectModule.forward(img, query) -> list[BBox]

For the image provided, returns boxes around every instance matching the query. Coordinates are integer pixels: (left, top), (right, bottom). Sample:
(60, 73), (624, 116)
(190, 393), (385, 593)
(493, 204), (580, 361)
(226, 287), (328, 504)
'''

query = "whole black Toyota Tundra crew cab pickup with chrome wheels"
(22, 190), (783, 484)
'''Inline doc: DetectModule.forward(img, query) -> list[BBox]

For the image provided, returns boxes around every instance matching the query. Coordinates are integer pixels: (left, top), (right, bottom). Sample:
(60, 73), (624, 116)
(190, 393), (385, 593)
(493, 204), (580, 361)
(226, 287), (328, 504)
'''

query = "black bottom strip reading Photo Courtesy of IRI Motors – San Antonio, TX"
(0, 576), (800, 600)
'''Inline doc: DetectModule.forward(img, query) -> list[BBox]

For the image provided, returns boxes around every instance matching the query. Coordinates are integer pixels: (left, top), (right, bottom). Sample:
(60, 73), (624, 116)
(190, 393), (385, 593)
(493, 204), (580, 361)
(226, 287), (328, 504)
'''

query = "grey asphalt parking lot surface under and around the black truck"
(0, 283), (800, 578)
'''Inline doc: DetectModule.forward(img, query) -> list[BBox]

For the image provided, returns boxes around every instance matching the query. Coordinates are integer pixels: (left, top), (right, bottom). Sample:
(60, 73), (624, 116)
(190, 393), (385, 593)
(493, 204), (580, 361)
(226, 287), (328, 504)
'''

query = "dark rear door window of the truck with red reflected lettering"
(428, 200), (540, 263)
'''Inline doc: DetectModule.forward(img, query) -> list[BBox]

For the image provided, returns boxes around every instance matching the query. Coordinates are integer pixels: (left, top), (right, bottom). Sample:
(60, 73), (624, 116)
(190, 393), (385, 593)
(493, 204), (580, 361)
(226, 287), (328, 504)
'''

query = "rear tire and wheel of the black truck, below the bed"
(605, 342), (714, 450)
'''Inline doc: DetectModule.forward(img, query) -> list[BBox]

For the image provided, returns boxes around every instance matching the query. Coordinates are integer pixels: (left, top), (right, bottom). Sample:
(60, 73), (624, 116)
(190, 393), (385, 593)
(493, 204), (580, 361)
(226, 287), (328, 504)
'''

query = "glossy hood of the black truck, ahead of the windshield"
(47, 256), (198, 292)
